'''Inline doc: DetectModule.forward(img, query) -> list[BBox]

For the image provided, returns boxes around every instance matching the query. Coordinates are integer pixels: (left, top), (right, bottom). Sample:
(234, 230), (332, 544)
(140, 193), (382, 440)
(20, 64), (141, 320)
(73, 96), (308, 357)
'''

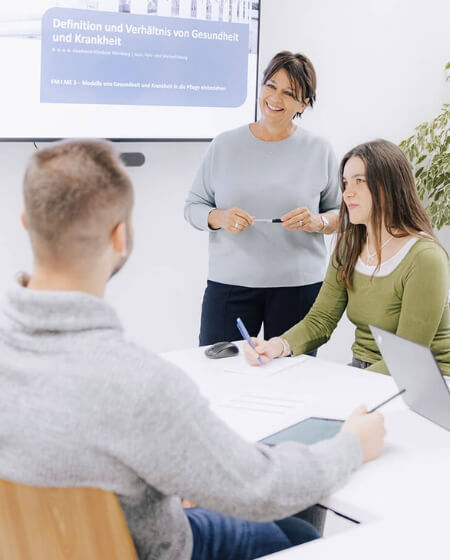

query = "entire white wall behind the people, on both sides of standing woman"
(0, 0), (450, 361)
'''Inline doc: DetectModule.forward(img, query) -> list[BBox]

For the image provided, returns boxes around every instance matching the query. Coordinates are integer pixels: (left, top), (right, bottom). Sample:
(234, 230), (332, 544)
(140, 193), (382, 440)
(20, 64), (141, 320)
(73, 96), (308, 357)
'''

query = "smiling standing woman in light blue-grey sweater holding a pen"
(185, 51), (340, 345)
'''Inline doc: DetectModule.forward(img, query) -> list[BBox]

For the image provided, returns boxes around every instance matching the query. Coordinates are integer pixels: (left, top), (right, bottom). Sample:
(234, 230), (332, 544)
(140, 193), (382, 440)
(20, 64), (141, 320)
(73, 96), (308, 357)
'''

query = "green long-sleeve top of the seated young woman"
(282, 239), (450, 375)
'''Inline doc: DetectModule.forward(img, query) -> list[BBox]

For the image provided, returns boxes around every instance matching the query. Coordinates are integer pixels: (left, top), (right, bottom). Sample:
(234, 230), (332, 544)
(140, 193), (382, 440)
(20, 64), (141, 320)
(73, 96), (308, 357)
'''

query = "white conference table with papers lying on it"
(163, 348), (450, 560)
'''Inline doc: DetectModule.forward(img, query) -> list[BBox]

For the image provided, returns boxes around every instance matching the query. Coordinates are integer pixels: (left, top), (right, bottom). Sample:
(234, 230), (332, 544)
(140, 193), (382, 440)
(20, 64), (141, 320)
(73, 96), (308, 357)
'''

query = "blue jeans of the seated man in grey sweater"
(185, 508), (319, 560)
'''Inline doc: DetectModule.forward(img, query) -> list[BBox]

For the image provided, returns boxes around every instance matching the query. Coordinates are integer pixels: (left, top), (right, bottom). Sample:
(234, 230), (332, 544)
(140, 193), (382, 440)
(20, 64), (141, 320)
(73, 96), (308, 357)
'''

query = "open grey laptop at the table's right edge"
(369, 325), (450, 431)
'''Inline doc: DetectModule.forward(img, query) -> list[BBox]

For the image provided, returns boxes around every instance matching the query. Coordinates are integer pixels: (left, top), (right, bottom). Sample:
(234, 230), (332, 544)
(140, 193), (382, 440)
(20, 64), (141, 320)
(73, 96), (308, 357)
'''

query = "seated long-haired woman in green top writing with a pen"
(244, 140), (450, 375)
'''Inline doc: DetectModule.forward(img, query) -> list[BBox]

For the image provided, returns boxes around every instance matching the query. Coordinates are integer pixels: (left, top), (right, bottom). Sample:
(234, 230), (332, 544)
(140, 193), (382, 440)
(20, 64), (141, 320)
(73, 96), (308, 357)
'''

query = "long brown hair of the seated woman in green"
(335, 140), (440, 289)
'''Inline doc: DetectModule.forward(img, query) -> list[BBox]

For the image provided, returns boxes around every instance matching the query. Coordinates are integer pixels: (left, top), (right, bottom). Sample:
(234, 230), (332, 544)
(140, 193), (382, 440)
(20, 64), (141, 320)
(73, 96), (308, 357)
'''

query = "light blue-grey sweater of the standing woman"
(185, 125), (341, 288)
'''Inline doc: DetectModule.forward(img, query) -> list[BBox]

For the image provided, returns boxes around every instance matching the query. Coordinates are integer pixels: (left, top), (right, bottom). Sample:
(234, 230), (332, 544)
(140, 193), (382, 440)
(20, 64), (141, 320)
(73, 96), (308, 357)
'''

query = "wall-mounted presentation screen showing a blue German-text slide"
(0, 0), (260, 140)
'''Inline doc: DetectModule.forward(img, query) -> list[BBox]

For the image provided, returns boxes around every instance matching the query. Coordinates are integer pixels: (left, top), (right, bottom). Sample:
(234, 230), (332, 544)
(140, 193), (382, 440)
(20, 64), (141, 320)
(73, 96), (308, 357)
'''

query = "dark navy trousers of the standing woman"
(200, 280), (322, 346)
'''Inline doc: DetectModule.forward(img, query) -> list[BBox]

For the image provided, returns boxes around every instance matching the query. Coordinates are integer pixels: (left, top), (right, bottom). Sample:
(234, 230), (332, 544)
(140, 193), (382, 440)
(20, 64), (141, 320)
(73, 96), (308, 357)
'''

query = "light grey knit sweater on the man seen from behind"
(0, 278), (361, 560)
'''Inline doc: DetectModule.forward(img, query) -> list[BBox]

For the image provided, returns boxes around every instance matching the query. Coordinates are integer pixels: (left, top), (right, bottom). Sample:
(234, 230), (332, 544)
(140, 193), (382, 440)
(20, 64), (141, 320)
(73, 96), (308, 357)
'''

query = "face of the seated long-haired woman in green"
(342, 156), (372, 226)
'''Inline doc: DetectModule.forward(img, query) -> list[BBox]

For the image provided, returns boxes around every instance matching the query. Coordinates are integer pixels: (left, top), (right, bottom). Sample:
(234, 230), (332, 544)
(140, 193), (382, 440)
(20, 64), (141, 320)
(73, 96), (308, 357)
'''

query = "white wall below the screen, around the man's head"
(0, 142), (208, 351)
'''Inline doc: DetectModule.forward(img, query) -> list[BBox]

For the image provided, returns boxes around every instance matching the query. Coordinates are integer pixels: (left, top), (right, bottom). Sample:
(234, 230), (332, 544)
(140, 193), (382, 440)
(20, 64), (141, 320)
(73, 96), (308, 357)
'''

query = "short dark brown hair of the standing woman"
(263, 51), (317, 118)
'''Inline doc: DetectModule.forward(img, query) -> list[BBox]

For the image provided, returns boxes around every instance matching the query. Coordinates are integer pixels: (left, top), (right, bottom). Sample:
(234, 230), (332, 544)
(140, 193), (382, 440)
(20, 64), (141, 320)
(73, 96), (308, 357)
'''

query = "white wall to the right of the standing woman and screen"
(260, 0), (450, 363)
